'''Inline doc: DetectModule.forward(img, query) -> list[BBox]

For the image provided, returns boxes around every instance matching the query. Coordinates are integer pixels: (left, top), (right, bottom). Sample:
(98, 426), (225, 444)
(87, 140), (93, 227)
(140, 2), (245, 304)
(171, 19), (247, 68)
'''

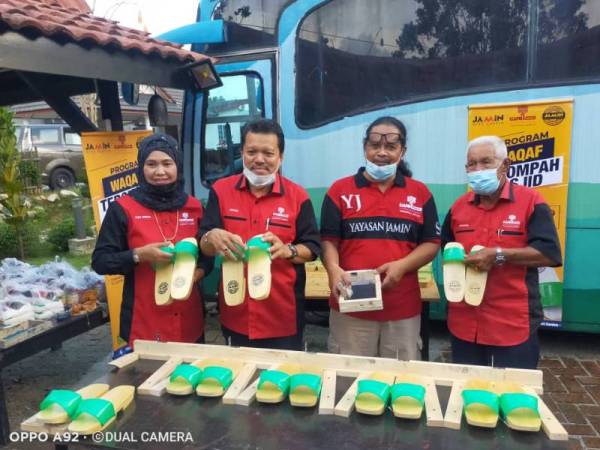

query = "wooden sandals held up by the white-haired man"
(442, 242), (487, 306)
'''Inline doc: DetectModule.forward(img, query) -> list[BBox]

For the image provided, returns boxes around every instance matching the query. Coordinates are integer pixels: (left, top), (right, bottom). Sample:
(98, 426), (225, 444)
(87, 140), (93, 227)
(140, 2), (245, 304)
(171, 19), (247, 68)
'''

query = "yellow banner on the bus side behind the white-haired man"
(469, 99), (573, 327)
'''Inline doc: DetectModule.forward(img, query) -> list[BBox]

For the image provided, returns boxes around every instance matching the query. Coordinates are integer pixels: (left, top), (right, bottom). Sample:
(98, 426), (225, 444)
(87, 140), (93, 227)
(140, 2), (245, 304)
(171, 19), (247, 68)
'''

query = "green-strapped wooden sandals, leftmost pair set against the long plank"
(167, 359), (242, 397)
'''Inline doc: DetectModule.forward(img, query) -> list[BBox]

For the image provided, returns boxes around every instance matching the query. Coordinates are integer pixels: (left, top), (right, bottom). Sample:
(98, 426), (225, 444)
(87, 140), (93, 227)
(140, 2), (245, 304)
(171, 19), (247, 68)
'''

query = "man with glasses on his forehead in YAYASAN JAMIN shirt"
(321, 117), (440, 360)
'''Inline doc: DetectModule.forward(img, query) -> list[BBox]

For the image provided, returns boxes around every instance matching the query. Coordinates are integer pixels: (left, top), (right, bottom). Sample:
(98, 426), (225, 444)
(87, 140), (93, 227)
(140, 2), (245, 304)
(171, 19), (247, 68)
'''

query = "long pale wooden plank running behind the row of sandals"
(135, 341), (543, 391)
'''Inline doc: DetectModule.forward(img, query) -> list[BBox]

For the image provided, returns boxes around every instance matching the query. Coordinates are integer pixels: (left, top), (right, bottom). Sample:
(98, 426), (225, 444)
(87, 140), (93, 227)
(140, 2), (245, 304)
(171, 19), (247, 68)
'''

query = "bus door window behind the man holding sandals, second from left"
(202, 73), (264, 182)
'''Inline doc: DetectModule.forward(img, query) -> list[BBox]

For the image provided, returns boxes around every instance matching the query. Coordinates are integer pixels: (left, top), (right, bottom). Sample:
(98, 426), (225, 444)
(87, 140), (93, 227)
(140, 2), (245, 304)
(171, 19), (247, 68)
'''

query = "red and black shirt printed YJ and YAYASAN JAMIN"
(321, 168), (440, 321)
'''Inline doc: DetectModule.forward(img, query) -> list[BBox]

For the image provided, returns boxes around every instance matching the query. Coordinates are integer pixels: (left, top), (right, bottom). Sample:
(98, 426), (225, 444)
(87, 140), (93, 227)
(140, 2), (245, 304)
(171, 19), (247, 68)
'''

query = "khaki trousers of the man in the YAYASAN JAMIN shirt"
(327, 309), (422, 361)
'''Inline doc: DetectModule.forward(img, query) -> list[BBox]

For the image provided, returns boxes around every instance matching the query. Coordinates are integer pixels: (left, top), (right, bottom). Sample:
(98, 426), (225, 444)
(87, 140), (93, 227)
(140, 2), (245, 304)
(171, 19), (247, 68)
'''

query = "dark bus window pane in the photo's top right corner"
(535, 0), (600, 81)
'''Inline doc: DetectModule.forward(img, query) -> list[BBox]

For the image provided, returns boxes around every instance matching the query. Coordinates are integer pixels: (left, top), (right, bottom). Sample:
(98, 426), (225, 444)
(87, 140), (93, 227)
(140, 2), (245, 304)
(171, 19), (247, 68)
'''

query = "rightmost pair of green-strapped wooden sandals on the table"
(462, 380), (542, 432)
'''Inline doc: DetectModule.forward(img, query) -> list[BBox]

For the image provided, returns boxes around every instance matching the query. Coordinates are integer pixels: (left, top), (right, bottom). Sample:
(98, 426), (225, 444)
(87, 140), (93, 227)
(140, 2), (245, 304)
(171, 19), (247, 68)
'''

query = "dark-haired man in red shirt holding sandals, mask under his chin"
(200, 120), (321, 350)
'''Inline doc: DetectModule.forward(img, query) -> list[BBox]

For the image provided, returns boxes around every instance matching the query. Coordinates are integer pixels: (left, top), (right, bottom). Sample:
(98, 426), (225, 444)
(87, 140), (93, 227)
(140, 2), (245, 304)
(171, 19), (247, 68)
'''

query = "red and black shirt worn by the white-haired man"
(442, 182), (562, 346)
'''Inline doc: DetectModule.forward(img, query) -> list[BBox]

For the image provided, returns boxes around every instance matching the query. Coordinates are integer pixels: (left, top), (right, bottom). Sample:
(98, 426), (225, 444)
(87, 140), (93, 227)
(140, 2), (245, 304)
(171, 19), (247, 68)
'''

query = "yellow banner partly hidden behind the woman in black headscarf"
(81, 130), (152, 349)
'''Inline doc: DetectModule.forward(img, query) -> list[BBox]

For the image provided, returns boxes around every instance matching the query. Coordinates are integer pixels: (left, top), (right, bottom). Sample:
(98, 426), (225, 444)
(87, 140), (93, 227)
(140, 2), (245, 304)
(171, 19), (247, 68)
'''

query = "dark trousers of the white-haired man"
(452, 331), (540, 369)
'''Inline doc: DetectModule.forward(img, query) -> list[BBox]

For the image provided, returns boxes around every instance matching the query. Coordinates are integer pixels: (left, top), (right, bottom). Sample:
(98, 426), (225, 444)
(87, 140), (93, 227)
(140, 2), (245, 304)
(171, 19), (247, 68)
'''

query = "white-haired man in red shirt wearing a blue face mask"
(442, 136), (562, 369)
